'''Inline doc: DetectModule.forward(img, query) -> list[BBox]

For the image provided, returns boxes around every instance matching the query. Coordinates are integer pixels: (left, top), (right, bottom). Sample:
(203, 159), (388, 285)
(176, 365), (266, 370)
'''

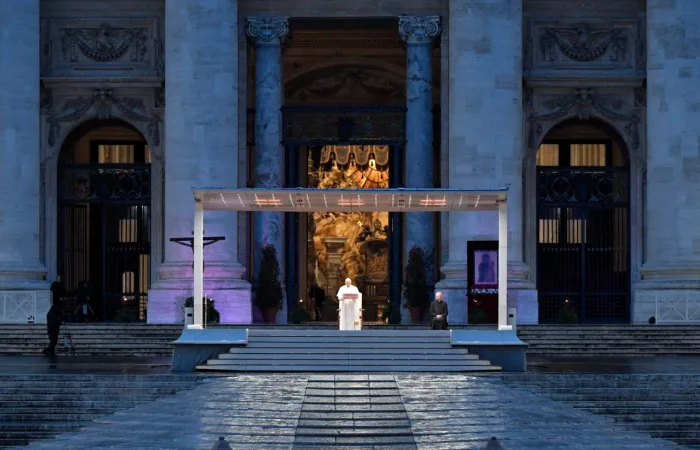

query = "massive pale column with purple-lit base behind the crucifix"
(148, 0), (252, 323)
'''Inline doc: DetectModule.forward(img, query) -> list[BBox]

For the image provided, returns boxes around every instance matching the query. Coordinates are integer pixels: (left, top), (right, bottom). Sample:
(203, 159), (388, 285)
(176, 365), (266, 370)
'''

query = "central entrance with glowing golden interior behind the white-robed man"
(284, 107), (405, 322)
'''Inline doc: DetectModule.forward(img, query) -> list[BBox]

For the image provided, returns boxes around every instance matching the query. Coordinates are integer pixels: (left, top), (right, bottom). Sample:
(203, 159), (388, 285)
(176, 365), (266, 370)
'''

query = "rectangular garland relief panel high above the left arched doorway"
(42, 18), (164, 77)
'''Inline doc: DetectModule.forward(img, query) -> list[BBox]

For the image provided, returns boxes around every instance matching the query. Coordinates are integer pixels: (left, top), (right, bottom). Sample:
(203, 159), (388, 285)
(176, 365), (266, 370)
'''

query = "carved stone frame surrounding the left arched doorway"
(40, 85), (165, 288)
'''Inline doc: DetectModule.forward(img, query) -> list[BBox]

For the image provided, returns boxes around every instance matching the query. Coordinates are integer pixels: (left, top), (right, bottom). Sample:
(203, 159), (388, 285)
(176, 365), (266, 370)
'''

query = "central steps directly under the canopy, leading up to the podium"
(197, 328), (501, 372)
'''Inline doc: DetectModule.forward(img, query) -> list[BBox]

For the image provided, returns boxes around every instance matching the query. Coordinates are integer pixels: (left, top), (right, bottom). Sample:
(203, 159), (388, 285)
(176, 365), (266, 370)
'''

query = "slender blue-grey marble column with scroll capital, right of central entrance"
(399, 16), (440, 294)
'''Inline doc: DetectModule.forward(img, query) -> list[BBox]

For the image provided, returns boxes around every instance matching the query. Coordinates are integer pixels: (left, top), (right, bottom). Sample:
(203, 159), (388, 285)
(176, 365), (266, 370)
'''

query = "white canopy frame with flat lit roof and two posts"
(188, 187), (512, 330)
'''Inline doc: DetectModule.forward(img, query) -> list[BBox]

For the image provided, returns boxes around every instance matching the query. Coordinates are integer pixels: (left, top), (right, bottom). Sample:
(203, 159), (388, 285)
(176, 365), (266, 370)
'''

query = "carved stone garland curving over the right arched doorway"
(526, 88), (643, 152)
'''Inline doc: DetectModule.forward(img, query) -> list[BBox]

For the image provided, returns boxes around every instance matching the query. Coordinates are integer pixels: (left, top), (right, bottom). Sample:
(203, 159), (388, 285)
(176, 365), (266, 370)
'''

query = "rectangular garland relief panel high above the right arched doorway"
(523, 19), (645, 76)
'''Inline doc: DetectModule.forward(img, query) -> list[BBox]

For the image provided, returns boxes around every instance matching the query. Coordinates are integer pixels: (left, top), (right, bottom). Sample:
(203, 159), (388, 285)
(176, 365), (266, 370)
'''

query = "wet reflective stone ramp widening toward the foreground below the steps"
(17, 373), (683, 450)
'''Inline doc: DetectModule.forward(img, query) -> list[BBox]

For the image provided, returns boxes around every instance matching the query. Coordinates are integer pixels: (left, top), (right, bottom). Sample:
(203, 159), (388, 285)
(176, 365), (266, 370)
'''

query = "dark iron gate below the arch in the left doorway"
(57, 164), (151, 321)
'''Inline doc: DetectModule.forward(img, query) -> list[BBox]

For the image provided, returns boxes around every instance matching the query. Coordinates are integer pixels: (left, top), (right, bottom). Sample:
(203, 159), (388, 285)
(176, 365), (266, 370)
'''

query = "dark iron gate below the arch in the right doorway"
(537, 159), (630, 323)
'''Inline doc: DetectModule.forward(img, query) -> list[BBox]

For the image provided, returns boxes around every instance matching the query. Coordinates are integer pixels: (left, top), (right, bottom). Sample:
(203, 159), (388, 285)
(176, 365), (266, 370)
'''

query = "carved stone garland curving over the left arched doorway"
(48, 89), (161, 147)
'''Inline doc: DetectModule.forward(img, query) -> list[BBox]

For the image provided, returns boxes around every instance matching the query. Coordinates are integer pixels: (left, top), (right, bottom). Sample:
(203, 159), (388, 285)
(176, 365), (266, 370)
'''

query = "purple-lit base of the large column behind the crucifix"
(148, 263), (253, 324)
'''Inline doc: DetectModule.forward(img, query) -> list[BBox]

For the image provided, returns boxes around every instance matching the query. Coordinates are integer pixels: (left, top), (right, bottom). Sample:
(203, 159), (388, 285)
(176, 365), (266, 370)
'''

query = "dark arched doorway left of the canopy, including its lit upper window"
(56, 120), (151, 321)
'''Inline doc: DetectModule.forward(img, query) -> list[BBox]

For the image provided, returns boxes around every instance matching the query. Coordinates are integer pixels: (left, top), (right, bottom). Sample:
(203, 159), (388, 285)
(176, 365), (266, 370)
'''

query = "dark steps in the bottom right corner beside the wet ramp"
(503, 373), (700, 448)
